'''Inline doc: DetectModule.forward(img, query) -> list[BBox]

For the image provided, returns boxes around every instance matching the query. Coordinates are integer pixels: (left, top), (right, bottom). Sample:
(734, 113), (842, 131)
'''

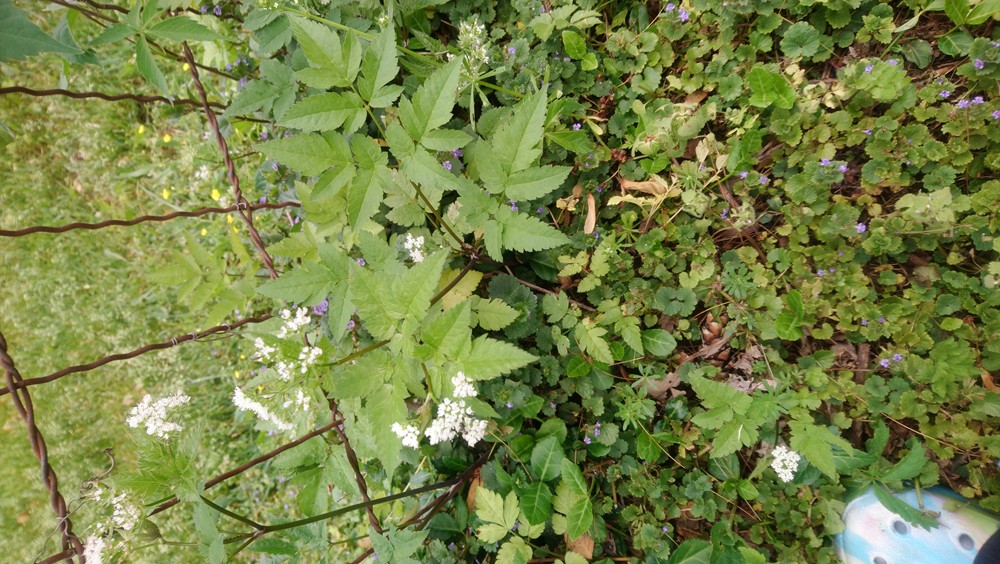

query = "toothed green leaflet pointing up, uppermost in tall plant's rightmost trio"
(491, 89), (546, 176)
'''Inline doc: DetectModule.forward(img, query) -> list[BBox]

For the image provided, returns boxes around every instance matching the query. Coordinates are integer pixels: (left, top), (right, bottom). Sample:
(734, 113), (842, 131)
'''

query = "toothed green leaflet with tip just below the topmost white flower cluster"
(399, 57), (462, 142)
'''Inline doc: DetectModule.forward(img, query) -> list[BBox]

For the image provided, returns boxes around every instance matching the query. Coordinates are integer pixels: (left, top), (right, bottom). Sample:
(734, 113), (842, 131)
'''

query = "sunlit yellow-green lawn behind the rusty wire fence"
(0, 51), (250, 562)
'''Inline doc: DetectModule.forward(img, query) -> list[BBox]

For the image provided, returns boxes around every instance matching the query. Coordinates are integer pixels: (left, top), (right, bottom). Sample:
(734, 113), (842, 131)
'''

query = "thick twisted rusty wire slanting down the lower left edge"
(0, 333), (83, 554)
